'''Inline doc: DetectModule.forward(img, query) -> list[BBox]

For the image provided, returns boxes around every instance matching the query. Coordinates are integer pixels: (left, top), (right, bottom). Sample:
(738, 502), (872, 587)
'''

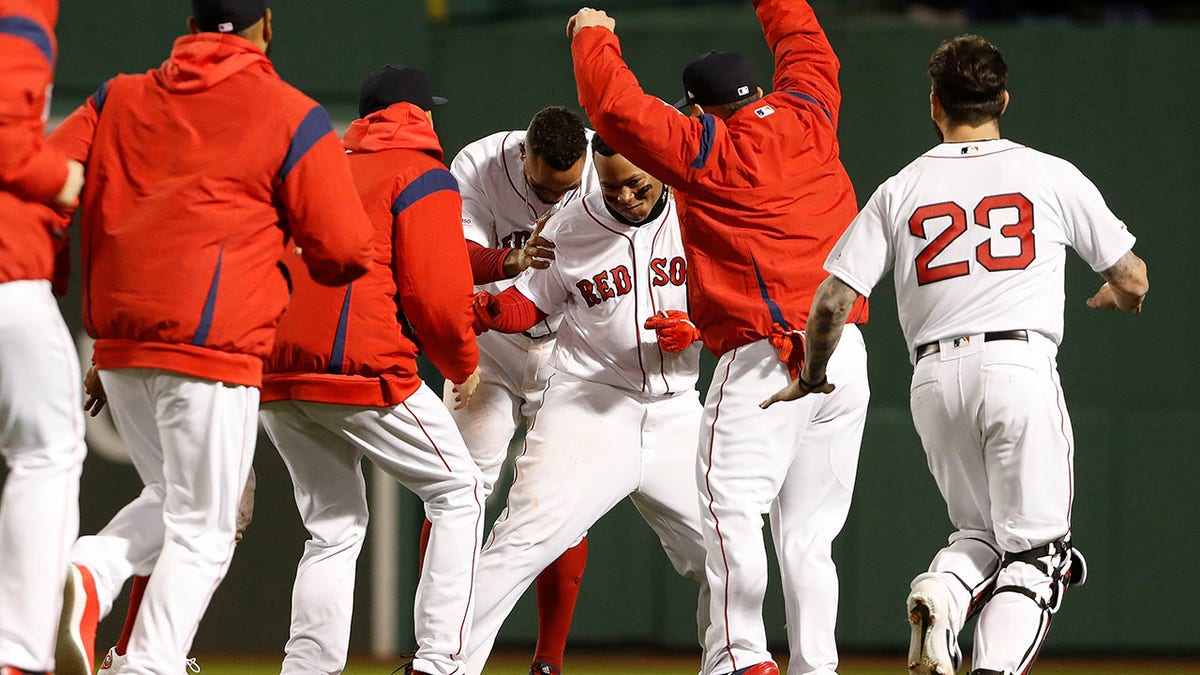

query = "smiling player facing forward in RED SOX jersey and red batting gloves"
(467, 136), (708, 674)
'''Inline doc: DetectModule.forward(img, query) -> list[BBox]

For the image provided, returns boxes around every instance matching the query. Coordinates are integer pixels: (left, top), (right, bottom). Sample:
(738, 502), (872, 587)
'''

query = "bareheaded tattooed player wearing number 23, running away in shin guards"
(764, 35), (1148, 675)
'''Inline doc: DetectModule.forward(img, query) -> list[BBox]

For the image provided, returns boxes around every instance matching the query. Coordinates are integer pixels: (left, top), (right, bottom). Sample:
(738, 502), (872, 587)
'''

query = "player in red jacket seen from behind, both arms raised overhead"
(568, 0), (870, 675)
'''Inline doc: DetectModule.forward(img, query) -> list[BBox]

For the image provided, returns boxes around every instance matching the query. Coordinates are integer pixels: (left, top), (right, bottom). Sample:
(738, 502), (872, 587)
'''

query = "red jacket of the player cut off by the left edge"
(0, 0), (67, 283)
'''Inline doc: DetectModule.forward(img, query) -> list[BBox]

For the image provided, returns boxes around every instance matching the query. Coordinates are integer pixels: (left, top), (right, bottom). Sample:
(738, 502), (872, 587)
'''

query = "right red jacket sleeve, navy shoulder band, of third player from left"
(391, 169), (479, 384)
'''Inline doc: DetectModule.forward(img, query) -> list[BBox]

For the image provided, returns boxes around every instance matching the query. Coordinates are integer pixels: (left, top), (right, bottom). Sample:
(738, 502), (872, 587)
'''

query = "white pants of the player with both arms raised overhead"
(697, 325), (870, 675)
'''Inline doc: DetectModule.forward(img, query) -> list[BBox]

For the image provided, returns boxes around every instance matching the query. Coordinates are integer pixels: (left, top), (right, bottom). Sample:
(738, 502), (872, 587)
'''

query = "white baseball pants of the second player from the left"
(71, 368), (258, 675)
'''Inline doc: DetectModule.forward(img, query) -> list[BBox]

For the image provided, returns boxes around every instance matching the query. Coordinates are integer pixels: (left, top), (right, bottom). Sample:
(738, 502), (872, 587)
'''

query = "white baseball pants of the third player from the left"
(260, 384), (485, 675)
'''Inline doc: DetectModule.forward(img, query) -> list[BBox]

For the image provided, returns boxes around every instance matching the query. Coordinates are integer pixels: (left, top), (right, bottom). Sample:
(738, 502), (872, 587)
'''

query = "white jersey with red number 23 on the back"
(824, 139), (1134, 358)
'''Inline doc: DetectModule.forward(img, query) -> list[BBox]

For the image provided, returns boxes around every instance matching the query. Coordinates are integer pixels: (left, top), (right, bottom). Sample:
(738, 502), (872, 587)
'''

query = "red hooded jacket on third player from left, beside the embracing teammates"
(263, 103), (479, 406)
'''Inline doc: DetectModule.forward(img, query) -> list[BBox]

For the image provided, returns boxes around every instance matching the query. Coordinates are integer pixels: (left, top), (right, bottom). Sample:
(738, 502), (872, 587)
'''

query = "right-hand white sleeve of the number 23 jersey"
(1058, 162), (1136, 271)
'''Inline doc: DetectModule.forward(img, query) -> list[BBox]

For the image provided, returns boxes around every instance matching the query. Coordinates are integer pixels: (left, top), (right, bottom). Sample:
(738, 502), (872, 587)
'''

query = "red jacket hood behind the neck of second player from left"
(155, 32), (275, 94)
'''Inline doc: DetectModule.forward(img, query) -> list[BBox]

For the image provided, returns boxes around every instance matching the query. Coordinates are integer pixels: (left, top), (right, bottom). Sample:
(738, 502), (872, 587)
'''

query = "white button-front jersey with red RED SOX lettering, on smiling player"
(516, 190), (700, 395)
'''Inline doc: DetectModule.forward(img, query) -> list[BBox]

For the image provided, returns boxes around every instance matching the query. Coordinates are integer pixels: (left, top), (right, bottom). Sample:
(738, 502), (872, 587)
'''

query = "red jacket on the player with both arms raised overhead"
(571, 0), (866, 354)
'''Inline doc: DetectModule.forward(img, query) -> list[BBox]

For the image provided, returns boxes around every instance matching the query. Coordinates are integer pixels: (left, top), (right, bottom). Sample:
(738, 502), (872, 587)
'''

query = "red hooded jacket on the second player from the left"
(50, 32), (371, 387)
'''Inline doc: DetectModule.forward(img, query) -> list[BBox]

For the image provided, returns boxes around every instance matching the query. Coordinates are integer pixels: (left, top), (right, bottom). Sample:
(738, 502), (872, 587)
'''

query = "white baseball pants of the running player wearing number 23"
(911, 331), (1074, 673)
